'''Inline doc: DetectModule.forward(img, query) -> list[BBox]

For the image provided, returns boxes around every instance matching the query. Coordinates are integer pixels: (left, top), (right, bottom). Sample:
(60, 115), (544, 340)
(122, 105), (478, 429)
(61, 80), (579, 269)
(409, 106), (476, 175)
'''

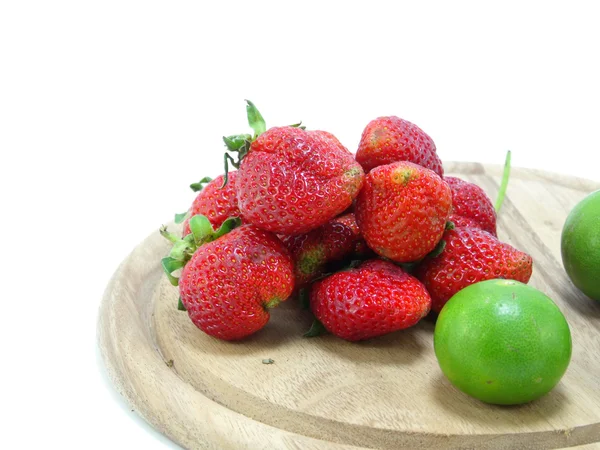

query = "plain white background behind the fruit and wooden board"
(0, 0), (600, 449)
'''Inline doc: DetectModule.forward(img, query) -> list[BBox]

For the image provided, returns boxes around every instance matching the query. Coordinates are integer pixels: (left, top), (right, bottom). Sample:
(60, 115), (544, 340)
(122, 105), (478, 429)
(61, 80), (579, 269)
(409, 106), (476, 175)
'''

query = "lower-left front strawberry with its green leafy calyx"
(161, 215), (294, 340)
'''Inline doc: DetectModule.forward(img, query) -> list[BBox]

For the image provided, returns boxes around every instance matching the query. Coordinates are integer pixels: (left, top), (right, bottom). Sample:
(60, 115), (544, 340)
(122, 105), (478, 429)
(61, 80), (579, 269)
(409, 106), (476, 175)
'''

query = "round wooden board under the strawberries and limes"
(98, 163), (600, 450)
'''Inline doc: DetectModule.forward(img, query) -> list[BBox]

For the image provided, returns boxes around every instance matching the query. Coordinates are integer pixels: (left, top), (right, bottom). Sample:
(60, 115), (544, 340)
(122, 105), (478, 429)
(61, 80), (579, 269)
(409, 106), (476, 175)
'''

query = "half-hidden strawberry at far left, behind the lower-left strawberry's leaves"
(183, 172), (241, 236)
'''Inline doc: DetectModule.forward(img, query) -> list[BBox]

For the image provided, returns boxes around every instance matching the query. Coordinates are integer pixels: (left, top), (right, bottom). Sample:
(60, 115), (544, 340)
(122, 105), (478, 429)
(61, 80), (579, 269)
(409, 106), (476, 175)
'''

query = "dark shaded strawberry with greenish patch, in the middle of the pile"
(282, 213), (366, 287)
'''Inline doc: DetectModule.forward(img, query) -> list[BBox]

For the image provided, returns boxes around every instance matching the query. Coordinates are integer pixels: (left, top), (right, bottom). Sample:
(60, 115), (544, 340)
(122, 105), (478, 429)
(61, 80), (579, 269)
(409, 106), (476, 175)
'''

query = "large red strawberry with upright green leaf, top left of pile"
(224, 102), (364, 235)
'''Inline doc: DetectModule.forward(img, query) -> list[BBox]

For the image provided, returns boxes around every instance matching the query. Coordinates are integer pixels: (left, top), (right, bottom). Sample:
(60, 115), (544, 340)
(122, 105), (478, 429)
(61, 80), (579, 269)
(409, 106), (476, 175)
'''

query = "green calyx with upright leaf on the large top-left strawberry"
(221, 100), (304, 188)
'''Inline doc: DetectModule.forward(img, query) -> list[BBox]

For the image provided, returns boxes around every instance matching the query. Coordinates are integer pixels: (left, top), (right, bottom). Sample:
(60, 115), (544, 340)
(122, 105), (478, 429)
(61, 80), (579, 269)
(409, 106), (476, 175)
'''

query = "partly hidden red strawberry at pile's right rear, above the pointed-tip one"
(444, 177), (496, 236)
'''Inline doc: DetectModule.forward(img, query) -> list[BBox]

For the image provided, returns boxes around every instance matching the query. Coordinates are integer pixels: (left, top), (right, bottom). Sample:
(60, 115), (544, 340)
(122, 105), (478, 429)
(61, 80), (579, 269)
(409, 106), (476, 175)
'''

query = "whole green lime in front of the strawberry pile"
(434, 280), (571, 405)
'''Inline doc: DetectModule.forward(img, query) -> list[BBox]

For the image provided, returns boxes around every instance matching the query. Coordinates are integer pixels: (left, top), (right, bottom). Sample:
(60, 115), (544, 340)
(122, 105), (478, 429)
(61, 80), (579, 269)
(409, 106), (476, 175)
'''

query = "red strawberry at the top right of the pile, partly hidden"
(356, 116), (444, 177)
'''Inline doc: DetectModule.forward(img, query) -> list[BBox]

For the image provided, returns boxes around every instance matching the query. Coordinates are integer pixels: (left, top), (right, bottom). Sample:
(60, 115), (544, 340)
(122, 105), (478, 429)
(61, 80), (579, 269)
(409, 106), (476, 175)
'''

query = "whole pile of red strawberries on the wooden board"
(161, 102), (532, 341)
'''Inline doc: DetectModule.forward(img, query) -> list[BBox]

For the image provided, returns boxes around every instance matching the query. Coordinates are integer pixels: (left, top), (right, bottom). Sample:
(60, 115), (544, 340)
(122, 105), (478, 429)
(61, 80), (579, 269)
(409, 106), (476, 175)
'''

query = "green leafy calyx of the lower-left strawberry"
(160, 214), (242, 310)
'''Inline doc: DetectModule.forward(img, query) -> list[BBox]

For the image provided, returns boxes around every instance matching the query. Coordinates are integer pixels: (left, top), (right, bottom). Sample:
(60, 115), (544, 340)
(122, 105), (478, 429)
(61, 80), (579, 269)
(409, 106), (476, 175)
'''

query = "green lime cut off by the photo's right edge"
(560, 190), (600, 301)
